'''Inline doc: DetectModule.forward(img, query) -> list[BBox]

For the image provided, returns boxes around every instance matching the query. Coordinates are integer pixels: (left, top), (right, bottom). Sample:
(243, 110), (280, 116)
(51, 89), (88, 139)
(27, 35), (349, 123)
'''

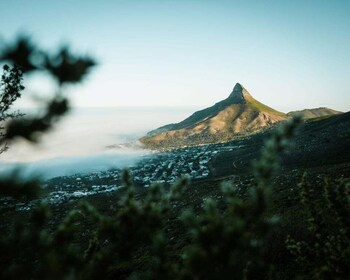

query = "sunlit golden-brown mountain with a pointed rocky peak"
(140, 83), (289, 148)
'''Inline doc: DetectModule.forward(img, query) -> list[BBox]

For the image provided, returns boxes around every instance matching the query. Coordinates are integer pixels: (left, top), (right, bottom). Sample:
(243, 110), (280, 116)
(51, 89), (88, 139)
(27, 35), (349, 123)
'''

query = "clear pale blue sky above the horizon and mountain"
(0, 0), (350, 112)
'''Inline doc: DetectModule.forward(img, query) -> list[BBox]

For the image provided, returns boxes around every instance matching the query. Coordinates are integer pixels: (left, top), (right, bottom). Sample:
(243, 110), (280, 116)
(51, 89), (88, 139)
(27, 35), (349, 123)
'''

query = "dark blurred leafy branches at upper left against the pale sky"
(0, 36), (96, 142)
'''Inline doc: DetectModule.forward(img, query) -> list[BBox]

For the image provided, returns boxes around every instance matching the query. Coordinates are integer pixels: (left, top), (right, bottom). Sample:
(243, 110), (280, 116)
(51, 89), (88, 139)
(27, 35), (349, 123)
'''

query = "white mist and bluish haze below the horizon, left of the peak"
(0, 108), (193, 178)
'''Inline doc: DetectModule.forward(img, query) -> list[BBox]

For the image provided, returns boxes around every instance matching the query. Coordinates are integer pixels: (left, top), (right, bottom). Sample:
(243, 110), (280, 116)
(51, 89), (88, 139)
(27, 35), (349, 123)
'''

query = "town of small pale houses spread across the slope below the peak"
(1, 143), (245, 210)
